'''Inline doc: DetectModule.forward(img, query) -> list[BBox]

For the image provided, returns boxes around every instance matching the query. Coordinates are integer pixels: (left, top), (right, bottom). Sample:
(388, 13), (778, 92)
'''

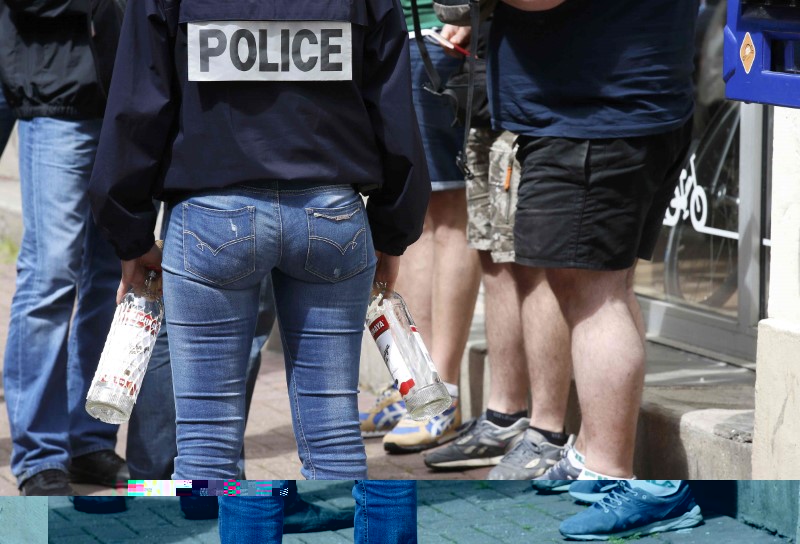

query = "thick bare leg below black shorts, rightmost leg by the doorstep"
(547, 269), (644, 478)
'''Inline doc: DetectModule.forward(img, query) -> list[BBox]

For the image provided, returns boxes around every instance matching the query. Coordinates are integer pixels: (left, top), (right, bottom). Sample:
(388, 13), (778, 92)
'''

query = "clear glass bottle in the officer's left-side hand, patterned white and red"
(86, 270), (164, 424)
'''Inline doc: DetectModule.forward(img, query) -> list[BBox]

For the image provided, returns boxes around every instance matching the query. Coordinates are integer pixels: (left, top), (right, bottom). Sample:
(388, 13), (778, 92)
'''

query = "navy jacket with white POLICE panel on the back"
(89, 0), (430, 260)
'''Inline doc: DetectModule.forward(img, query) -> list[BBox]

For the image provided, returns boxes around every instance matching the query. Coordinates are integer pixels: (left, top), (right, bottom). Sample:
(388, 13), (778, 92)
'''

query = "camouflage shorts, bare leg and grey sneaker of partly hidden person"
(425, 128), (549, 472)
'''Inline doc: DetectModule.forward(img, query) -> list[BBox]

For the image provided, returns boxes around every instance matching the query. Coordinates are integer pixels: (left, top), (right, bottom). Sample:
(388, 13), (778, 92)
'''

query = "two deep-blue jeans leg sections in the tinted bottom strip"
(219, 480), (417, 544)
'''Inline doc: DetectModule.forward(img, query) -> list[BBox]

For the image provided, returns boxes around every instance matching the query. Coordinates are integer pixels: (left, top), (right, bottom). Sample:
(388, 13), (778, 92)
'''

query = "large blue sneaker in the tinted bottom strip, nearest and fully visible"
(558, 480), (703, 540)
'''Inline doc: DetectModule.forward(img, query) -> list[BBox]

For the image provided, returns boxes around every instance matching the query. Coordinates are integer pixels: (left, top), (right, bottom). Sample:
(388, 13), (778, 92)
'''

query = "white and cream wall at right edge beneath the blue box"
(753, 108), (800, 479)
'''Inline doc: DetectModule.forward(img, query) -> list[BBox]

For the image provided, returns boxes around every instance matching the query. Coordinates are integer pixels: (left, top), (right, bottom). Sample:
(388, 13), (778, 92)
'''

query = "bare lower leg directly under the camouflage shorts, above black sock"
(478, 251), (528, 414)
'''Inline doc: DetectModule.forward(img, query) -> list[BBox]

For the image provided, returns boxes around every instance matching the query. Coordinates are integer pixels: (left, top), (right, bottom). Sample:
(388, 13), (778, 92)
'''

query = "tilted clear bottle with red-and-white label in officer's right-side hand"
(366, 286), (453, 420)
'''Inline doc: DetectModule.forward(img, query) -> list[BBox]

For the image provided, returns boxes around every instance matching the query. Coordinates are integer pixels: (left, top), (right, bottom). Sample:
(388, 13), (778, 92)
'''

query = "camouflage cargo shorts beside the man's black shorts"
(467, 128), (521, 263)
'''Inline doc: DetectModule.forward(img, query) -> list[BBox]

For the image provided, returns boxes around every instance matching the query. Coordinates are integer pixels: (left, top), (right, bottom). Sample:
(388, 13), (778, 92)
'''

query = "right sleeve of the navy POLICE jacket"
(362, 0), (431, 255)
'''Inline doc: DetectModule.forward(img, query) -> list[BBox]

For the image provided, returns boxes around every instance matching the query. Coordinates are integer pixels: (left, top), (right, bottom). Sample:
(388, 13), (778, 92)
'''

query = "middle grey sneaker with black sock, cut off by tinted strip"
(489, 428), (575, 480)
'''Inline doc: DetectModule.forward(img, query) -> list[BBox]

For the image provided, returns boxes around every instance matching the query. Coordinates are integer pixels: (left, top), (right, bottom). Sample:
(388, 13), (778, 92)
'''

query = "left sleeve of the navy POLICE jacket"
(89, 0), (178, 260)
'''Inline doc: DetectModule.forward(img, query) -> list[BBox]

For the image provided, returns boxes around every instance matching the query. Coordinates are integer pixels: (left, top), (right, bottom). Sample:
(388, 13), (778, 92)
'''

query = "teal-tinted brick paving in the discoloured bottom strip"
(49, 481), (788, 544)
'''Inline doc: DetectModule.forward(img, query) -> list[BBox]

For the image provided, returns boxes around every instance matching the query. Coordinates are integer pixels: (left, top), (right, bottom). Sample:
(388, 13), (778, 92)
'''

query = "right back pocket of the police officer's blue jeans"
(305, 202), (367, 282)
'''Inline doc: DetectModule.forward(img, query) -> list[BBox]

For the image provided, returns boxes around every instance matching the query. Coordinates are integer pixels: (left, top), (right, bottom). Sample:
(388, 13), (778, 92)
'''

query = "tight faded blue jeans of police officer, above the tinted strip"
(163, 182), (376, 479)
